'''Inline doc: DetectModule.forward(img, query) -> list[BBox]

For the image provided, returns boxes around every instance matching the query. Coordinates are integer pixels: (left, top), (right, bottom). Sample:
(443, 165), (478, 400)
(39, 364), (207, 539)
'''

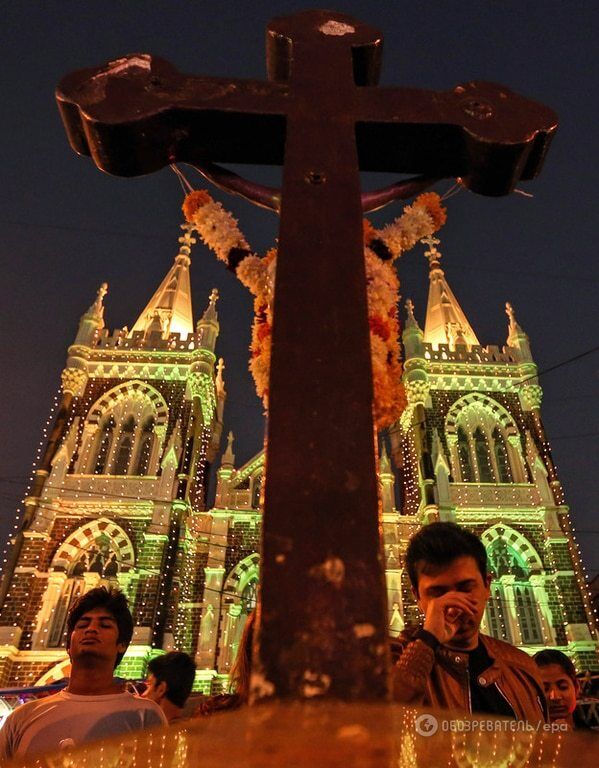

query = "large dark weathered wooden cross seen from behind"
(57, 11), (556, 699)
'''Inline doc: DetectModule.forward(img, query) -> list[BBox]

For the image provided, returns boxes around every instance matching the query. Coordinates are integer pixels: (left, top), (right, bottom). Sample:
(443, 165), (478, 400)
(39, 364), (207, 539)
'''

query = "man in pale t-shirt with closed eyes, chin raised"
(0, 587), (166, 760)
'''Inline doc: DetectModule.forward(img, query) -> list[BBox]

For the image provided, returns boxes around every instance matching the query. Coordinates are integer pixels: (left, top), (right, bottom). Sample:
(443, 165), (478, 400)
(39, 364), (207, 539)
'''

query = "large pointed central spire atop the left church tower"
(130, 224), (196, 338)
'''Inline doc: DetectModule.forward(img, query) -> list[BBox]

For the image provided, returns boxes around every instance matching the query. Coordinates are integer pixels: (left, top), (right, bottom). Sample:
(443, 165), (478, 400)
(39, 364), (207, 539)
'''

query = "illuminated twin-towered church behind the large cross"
(0, 225), (599, 692)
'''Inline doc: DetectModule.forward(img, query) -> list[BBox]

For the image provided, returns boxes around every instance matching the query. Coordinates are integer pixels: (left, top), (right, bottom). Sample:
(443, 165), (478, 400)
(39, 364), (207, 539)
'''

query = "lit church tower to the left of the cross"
(0, 225), (225, 685)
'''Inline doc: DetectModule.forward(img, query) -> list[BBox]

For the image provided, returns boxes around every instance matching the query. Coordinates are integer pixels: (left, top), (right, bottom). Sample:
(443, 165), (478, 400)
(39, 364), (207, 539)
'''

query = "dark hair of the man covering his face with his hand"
(406, 523), (487, 594)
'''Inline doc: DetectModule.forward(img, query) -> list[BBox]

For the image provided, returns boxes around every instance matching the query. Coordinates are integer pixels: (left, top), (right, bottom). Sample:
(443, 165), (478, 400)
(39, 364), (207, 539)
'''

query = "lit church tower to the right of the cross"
(384, 238), (599, 670)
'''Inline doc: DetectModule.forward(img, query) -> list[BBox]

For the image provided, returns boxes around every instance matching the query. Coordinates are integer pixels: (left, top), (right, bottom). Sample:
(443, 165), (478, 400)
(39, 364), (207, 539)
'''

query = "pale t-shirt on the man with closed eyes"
(0, 691), (167, 760)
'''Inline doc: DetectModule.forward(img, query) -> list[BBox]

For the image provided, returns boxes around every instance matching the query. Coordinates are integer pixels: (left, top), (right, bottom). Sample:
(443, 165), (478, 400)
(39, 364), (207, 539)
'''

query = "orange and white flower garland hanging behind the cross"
(183, 190), (447, 429)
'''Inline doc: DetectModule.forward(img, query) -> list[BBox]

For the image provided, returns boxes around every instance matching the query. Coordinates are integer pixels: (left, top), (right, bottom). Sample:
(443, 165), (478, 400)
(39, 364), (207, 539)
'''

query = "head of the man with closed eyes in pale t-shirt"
(67, 587), (133, 669)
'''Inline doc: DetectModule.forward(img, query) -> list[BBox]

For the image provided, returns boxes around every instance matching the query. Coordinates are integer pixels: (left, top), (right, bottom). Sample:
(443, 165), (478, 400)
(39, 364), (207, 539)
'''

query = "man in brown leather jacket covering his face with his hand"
(392, 523), (547, 723)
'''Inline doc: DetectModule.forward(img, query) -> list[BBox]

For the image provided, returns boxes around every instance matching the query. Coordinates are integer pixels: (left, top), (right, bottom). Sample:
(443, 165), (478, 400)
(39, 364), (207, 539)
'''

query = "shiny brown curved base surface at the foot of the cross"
(23, 701), (597, 768)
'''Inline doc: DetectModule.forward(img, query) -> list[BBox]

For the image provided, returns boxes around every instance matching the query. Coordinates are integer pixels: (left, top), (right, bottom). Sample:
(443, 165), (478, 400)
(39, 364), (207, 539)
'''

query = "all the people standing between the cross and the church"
(0, 522), (585, 760)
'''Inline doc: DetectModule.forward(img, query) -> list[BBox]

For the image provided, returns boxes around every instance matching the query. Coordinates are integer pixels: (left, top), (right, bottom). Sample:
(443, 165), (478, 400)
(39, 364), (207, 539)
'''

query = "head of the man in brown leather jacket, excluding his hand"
(406, 523), (491, 646)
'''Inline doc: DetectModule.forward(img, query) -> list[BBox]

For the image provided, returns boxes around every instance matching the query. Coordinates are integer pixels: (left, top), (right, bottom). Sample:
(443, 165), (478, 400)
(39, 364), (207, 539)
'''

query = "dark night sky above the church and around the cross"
(0, 0), (599, 574)
